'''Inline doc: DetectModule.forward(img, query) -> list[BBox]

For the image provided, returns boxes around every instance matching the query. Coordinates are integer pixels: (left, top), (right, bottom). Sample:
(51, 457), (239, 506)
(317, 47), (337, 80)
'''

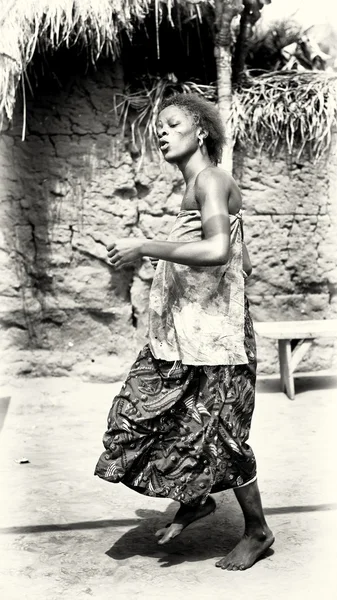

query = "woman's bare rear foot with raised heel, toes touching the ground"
(156, 496), (216, 544)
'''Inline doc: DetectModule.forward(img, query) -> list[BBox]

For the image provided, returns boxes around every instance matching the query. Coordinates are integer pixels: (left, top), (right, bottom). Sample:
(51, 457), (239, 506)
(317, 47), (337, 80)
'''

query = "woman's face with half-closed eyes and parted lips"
(157, 105), (200, 163)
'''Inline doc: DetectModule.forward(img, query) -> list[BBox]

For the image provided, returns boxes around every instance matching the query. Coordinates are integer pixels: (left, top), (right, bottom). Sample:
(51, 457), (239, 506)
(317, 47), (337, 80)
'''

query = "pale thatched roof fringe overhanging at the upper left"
(0, 0), (207, 125)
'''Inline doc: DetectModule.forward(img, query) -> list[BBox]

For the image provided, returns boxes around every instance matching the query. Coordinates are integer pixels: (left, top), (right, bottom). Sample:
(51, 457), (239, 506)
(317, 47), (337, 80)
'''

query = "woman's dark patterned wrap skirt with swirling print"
(95, 300), (256, 504)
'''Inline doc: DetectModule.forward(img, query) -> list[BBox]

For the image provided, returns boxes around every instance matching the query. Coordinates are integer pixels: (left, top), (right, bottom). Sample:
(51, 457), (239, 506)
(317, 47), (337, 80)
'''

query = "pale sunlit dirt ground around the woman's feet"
(0, 374), (337, 600)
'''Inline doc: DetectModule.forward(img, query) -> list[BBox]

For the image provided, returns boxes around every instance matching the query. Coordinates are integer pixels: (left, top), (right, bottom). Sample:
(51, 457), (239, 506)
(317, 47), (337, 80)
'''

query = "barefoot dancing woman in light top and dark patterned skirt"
(95, 94), (274, 570)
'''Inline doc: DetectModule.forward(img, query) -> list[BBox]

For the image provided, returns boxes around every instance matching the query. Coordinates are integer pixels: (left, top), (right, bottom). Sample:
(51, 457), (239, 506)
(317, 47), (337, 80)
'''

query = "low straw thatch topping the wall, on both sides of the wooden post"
(116, 71), (337, 161)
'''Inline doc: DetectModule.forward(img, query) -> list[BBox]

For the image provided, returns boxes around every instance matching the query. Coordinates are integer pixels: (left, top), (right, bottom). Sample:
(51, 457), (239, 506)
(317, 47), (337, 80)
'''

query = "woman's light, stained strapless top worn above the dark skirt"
(149, 209), (248, 366)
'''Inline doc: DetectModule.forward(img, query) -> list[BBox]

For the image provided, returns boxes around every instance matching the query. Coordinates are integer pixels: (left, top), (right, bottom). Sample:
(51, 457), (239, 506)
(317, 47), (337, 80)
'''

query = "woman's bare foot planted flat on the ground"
(215, 527), (275, 571)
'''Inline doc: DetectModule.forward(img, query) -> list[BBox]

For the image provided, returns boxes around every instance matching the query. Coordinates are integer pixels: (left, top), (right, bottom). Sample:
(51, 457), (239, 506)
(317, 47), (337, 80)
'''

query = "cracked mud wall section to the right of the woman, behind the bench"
(235, 150), (337, 373)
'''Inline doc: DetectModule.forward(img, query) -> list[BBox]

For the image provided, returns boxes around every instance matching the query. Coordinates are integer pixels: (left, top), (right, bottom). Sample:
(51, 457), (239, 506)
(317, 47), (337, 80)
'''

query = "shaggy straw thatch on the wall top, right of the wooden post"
(232, 71), (337, 161)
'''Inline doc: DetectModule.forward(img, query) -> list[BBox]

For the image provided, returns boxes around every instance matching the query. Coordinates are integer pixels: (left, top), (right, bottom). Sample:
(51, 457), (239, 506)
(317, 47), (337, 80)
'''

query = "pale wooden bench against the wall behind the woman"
(254, 319), (337, 400)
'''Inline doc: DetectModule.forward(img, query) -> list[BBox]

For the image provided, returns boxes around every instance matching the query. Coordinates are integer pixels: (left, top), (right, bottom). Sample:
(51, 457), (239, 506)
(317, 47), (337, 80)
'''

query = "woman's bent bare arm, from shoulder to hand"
(107, 167), (230, 268)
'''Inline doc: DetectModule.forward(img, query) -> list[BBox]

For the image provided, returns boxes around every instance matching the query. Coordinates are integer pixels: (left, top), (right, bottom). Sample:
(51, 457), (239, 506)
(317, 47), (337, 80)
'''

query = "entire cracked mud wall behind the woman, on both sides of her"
(0, 64), (337, 380)
